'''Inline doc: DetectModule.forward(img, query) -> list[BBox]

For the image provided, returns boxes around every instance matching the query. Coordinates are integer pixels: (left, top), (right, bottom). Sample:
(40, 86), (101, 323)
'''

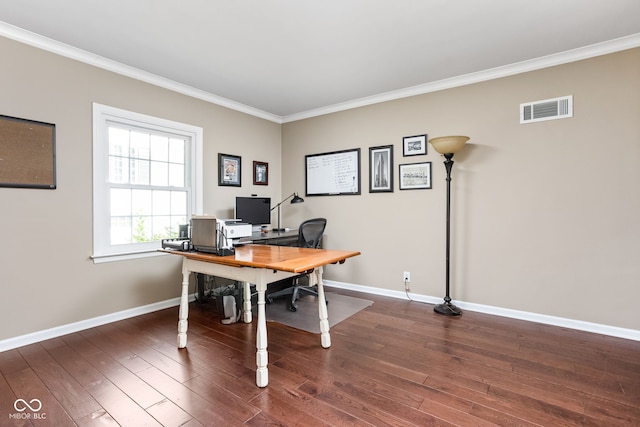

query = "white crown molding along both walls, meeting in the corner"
(0, 21), (640, 124)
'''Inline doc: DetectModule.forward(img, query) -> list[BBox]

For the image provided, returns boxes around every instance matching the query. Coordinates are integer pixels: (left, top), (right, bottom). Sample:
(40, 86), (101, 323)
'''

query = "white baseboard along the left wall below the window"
(0, 294), (195, 352)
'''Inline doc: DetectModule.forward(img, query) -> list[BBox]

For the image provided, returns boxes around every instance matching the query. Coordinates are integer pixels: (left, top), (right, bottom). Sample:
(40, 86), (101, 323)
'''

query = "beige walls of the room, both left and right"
(0, 38), (640, 340)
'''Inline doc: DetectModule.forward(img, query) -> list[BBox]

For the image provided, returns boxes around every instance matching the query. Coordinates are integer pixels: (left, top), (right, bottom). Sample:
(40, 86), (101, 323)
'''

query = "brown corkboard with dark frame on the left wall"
(0, 115), (56, 189)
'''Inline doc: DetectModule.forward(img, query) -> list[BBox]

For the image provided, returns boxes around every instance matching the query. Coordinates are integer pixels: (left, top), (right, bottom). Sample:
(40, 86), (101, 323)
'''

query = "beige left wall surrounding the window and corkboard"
(0, 38), (281, 340)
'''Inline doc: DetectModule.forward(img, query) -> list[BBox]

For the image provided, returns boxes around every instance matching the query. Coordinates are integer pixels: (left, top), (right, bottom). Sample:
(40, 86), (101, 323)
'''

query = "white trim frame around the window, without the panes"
(91, 103), (204, 263)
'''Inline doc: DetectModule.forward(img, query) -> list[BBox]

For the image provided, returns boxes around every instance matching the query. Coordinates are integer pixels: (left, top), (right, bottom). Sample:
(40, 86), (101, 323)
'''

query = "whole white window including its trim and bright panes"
(93, 104), (203, 262)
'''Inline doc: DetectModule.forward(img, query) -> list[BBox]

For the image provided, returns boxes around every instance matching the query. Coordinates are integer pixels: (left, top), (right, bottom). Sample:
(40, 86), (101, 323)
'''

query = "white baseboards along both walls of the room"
(0, 280), (640, 352)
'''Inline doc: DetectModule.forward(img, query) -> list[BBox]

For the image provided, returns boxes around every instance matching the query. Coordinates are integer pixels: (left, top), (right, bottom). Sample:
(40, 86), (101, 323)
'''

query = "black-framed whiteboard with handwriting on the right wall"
(305, 148), (360, 196)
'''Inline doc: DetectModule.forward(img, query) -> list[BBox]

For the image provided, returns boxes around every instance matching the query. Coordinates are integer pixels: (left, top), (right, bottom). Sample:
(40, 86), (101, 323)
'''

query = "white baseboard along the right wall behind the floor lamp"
(324, 280), (640, 341)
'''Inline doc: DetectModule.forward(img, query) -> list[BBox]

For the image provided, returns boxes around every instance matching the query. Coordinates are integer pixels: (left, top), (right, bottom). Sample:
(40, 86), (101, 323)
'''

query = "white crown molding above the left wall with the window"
(0, 21), (282, 124)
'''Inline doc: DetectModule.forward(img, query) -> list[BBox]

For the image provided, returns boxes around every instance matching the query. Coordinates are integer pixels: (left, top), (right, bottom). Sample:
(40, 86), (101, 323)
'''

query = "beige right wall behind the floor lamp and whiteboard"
(282, 49), (640, 330)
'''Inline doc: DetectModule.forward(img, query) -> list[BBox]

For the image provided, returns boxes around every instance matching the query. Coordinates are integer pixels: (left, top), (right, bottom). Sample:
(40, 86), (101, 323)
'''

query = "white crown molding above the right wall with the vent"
(282, 33), (640, 123)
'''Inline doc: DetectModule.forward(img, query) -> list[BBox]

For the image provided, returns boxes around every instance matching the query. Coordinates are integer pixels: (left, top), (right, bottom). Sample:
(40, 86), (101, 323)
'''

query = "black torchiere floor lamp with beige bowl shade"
(429, 136), (469, 316)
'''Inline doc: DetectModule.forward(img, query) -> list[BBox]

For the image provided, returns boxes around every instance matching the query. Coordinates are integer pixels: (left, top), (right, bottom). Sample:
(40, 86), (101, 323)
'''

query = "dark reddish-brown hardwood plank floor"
(0, 290), (640, 427)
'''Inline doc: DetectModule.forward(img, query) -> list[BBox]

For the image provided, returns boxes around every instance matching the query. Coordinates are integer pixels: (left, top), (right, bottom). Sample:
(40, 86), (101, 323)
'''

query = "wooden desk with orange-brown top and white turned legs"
(164, 244), (360, 387)
